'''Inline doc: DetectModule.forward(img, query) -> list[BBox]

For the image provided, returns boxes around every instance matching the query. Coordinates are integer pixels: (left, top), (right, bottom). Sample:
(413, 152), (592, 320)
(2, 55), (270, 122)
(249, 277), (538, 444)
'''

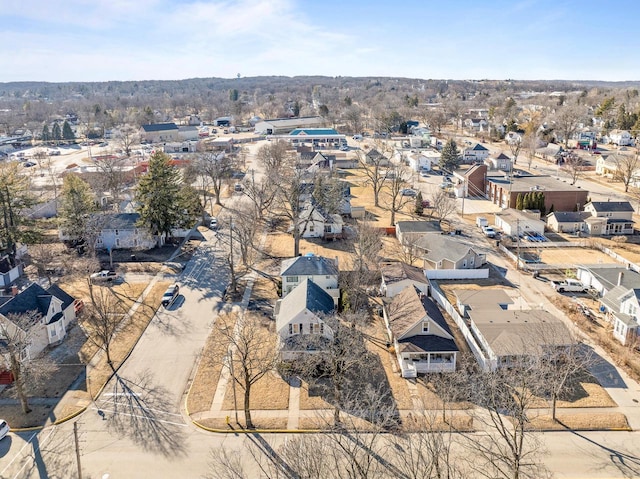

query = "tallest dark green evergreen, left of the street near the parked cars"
(136, 151), (183, 236)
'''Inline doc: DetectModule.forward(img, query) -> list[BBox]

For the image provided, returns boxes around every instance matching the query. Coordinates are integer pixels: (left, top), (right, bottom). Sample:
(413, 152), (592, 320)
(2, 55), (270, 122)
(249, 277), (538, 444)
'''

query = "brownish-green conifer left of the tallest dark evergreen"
(58, 175), (96, 241)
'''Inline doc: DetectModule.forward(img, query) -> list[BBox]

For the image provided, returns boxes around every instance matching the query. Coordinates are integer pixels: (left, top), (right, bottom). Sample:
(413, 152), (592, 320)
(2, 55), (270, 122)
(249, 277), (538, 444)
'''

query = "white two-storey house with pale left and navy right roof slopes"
(274, 279), (335, 360)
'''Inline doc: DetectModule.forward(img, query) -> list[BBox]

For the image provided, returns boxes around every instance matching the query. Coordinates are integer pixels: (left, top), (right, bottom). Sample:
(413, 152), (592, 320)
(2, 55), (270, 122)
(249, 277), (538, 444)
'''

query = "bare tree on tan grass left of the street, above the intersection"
(80, 281), (126, 369)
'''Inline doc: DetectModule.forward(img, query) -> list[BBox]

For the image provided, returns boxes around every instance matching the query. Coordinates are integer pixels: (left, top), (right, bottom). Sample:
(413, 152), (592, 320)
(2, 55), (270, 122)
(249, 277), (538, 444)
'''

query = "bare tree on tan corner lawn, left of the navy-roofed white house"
(213, 314), (280, 429)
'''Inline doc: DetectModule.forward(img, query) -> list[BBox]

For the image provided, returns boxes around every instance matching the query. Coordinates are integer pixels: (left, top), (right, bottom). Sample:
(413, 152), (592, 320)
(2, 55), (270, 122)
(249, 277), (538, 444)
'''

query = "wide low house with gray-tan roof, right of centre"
(413, 235), (487, 269)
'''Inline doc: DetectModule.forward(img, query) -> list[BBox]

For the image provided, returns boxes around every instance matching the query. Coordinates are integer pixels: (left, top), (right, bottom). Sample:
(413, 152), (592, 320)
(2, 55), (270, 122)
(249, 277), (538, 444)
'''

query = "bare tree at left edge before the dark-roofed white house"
(0, 311), (46, 414)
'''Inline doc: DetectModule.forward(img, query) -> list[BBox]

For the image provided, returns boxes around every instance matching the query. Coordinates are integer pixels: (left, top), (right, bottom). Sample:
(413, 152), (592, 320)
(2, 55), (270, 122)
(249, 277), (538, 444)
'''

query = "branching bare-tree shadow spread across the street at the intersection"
(98, 371), (186, 457)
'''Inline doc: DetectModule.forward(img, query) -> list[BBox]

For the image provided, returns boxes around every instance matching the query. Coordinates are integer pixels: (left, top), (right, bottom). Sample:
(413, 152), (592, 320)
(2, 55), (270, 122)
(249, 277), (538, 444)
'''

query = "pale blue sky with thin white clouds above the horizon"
(0, 0), (640, 82)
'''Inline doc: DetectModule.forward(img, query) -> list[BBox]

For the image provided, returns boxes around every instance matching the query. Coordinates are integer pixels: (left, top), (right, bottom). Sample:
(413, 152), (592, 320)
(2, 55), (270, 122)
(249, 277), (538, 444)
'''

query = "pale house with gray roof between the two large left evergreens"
(95, 213), (165, 250)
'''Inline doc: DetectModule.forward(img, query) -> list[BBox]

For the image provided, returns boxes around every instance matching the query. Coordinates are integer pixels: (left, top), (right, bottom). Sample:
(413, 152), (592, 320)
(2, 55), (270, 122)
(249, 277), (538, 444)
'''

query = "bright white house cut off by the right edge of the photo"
(600, 285), (640, 346)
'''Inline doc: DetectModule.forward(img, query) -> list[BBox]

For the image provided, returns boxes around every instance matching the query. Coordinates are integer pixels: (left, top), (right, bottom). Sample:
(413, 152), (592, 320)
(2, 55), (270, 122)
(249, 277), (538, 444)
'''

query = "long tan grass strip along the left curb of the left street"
(88, 281), (171, 397)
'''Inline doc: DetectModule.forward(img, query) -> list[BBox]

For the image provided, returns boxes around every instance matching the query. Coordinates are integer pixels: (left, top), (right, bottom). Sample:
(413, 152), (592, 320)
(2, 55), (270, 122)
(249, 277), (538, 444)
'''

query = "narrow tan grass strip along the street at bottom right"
(528, 412), (631, 431)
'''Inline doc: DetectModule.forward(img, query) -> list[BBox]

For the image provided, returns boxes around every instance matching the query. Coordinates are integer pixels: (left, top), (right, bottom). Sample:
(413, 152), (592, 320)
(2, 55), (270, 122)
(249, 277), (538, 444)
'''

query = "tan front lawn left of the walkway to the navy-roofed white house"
(222, 372), (289, 410)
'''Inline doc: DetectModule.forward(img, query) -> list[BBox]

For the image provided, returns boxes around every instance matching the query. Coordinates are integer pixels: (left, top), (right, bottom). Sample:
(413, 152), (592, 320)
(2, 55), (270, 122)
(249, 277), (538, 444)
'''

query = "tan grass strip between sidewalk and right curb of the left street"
(187, 313), (237, 414)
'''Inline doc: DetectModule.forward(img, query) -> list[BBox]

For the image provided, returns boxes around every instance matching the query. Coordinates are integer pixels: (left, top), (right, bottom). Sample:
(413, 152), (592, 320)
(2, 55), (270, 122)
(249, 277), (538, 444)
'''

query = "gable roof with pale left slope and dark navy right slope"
(276, 279), (335, 331)
